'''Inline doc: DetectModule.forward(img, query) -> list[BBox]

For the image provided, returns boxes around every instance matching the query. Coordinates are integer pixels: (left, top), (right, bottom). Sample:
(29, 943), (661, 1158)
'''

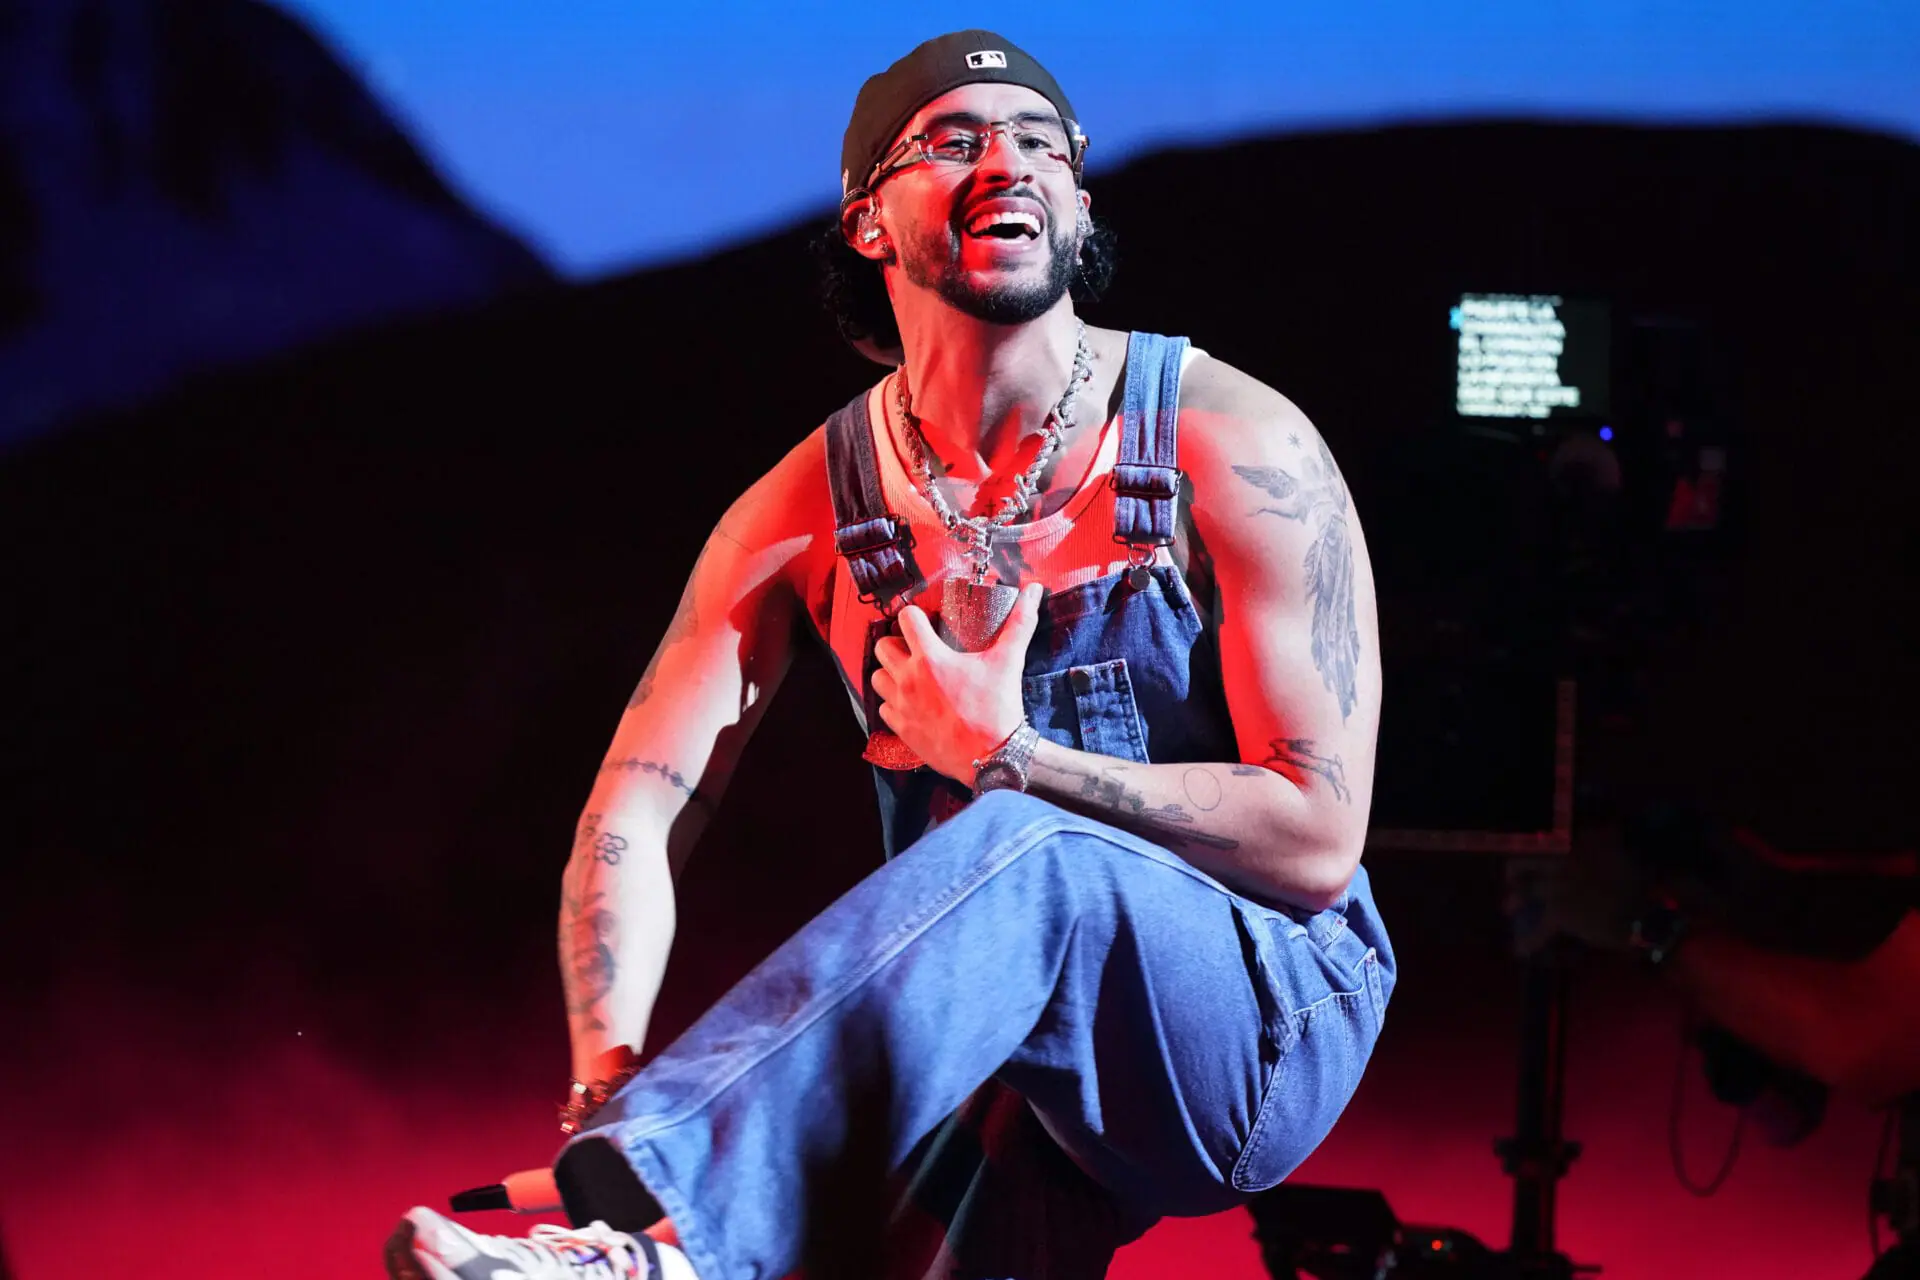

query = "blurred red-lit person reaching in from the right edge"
(1507, 806), (1920, 1280)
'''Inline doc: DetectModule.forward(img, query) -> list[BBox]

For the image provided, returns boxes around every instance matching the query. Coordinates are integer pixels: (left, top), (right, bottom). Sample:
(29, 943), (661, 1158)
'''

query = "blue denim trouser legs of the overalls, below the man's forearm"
(559, 793), (1392, 1280)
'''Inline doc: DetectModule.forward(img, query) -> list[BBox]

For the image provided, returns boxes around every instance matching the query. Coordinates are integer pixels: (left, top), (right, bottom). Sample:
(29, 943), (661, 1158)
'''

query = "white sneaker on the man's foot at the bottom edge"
(386, 1209), (660, 1280)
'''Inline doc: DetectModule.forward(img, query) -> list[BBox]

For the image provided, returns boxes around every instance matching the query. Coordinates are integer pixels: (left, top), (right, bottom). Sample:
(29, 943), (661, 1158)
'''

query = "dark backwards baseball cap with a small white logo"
(841, 31), (1079, 196)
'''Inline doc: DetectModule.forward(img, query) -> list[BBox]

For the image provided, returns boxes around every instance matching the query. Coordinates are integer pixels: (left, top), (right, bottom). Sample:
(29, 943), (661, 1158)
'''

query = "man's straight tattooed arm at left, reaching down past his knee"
(559, 432), (833, 1079)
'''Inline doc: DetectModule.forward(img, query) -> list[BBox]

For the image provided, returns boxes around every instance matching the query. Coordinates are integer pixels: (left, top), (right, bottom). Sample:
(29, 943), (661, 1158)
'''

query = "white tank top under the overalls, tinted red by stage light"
(828, 345), (1206, 733)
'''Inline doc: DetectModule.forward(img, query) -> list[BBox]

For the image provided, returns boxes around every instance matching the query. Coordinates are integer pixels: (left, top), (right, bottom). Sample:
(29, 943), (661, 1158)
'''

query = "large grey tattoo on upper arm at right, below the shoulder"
(1233, 439), (1359, 722)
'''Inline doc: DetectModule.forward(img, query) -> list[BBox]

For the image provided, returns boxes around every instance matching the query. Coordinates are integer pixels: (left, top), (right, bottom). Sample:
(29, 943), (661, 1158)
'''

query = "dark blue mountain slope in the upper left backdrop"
(0, 0), (549, 447)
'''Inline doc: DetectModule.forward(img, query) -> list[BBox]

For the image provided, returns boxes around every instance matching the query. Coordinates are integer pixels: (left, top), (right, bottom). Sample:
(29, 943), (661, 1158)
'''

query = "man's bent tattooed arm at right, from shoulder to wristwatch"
(1033, 359), (1380, 910)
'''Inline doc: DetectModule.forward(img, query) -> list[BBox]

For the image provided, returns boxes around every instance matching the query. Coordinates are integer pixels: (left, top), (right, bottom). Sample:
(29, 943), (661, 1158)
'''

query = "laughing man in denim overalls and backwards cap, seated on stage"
(388, 31), (1394, 1280)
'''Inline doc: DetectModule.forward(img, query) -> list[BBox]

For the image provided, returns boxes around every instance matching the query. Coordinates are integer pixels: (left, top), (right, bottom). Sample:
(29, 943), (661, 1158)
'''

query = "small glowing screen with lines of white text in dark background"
(1450, 294), (1611, 418)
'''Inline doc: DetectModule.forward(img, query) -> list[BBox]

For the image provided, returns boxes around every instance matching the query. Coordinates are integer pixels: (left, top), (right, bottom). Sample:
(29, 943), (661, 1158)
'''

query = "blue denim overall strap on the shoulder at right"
(1110, 334), (1187, 551)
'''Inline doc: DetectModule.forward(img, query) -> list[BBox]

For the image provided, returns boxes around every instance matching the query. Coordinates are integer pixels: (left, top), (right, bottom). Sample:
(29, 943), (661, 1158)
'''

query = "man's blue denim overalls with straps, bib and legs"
(557, 334), (1394, 1280)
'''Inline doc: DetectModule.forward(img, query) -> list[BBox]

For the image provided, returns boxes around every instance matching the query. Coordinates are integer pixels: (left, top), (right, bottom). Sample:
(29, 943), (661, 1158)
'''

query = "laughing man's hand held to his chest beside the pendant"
(874, 583), (1044, 785)
